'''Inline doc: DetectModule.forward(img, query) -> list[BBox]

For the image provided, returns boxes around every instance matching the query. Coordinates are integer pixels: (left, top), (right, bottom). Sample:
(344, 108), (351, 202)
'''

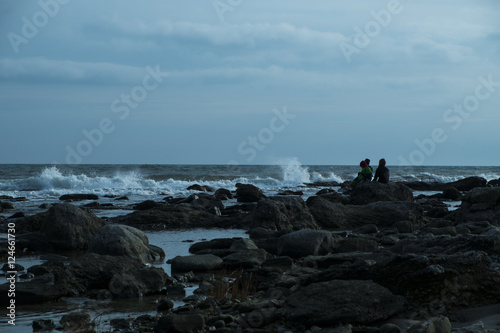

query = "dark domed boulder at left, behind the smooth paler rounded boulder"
(40, 203), (104, 251)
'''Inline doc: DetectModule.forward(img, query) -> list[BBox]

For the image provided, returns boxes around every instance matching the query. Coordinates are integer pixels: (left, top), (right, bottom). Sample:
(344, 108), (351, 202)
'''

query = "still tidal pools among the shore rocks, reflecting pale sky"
(0, 229), (248, 333)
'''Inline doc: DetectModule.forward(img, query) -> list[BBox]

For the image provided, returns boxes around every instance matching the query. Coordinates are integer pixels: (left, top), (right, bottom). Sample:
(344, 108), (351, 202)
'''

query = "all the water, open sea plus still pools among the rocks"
(0, 158), (500, 332)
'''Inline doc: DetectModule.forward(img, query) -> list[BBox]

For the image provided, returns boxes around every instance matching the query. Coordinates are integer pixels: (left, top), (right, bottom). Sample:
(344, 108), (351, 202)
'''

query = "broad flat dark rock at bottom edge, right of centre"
(284, 280), (404, 326)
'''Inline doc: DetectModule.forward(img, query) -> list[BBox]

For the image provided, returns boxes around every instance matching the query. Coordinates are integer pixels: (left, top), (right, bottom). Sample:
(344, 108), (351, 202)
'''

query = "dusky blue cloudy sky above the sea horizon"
(0, 0), (500, 166)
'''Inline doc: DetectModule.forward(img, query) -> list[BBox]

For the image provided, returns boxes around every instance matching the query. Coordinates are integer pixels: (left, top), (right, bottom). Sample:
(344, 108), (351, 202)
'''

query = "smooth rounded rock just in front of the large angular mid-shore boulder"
(277, 229), (334, 258)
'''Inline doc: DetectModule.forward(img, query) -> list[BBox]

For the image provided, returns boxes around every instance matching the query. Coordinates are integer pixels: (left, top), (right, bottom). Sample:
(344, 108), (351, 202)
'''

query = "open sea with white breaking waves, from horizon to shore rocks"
(0, 158), (500, 217)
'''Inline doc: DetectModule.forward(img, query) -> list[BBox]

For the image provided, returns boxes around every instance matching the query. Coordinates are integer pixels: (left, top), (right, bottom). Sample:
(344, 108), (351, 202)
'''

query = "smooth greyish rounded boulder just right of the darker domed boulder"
(88, 224), (165, 263)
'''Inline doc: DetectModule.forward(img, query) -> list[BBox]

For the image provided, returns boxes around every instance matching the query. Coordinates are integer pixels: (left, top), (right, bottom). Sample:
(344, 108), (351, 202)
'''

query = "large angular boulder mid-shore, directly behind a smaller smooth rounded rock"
(247, 197), (319, 230)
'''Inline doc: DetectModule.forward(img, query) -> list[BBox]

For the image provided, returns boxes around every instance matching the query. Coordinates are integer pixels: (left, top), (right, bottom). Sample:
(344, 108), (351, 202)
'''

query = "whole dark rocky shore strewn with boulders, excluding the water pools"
(0, 177), (500, 333)
